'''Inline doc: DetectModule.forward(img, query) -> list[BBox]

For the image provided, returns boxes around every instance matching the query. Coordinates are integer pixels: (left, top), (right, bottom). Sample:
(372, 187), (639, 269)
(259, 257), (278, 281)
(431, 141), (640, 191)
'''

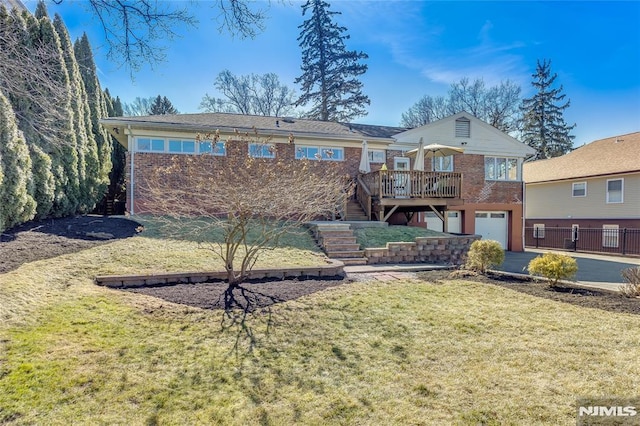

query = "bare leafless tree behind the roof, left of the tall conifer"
(200, 70), (295, 117)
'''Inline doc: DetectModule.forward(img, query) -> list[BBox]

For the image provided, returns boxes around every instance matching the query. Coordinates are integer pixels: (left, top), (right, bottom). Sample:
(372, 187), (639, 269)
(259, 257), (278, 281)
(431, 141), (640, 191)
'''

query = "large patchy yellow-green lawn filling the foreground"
(0, 237), (640, 425)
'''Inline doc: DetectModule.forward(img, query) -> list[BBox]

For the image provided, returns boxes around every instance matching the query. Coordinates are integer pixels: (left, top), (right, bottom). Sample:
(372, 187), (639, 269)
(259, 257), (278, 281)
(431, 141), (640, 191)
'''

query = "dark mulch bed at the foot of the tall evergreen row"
(0, 215), (141, 273)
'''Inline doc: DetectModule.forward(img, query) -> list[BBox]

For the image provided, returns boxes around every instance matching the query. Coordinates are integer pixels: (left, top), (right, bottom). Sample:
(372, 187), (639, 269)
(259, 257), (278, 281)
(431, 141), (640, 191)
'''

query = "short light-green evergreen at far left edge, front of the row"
(0, 92), (36, 232)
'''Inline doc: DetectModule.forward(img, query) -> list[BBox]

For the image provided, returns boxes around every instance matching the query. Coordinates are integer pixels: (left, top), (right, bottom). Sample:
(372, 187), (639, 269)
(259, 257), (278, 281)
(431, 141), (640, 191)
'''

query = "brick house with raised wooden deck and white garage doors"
(101, 113), (534, 251)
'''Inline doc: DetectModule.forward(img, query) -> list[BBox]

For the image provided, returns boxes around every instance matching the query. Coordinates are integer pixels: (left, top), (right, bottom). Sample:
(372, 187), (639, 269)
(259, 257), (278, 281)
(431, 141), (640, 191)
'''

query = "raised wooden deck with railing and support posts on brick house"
(356, 170), (463, 221)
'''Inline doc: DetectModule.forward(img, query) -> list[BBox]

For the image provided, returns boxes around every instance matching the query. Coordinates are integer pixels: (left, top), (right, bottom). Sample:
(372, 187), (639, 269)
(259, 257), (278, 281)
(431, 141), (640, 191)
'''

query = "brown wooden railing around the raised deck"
(359, 170), (462, 198)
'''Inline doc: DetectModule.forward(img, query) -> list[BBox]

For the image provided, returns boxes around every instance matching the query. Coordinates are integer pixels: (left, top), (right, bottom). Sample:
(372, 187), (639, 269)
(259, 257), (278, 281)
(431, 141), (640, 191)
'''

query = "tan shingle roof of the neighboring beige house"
(524, 132), (640, 183)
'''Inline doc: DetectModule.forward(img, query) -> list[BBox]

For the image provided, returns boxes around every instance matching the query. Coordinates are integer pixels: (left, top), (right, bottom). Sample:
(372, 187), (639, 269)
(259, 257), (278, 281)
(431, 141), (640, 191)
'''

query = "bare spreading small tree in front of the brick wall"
(139, 134), (347, 291)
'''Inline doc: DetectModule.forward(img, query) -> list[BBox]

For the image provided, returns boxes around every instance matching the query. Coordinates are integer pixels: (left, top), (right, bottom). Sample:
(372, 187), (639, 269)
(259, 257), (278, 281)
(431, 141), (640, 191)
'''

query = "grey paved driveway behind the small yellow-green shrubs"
(496, 250), (640, 283)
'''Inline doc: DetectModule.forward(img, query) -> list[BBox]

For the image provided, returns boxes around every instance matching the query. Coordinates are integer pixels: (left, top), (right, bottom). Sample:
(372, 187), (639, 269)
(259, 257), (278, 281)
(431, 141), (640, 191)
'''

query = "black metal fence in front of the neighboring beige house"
(525, 226), (640, 255)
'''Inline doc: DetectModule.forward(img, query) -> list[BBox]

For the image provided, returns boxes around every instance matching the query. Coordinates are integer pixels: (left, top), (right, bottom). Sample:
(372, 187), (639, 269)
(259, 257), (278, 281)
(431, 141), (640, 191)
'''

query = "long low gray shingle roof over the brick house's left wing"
(101, 113), (405, 139)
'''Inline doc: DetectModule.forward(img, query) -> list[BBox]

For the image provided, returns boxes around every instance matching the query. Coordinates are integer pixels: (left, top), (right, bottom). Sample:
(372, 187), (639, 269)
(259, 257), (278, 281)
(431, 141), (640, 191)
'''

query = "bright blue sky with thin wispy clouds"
(25, 0), (640, 146)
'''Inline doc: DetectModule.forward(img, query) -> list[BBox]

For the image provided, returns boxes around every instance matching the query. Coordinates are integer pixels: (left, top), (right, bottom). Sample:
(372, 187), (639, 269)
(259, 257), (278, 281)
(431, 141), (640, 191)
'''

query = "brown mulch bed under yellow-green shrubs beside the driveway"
(418, 271), (640, 315)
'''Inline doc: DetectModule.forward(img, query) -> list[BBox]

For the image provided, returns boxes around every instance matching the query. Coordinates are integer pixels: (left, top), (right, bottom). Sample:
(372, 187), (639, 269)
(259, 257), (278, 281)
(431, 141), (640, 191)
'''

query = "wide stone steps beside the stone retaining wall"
(312, 222), (367, 265)
